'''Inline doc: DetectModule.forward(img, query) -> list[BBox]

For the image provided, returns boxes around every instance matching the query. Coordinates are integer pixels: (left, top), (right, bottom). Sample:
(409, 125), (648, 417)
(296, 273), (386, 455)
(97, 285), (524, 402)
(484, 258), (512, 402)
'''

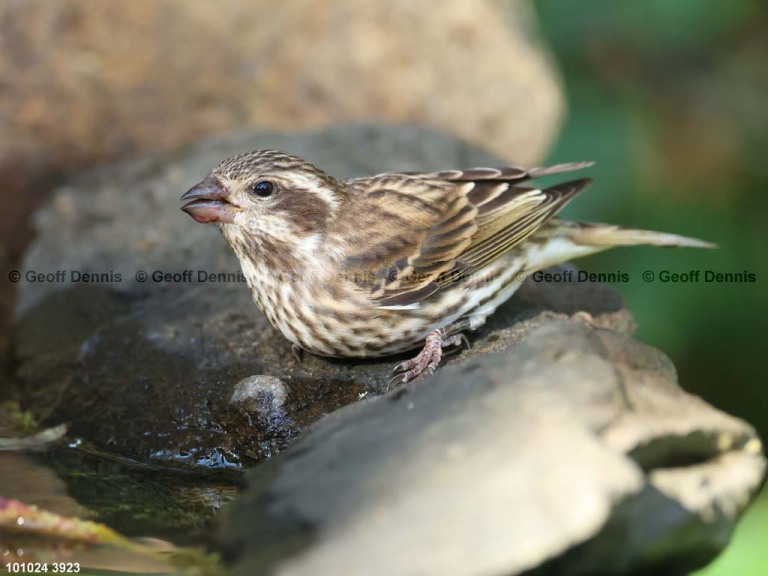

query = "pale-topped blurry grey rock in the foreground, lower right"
(220, 321), (765, 576)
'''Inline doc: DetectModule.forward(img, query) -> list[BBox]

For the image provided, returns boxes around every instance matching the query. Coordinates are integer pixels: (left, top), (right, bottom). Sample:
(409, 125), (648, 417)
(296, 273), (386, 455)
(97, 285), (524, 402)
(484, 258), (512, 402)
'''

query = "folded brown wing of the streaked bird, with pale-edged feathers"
(342, 163), (590, 309)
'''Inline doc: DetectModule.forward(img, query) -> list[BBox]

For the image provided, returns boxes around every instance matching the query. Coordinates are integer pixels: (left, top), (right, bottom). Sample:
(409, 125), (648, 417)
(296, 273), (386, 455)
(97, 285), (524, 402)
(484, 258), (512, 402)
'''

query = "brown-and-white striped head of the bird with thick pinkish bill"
(181, 150), (346, 244)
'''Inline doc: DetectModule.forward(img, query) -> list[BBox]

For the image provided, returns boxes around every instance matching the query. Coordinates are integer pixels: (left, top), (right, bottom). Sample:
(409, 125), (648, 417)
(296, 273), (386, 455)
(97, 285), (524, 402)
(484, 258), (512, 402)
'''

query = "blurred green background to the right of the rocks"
(536, 0), (768, 576)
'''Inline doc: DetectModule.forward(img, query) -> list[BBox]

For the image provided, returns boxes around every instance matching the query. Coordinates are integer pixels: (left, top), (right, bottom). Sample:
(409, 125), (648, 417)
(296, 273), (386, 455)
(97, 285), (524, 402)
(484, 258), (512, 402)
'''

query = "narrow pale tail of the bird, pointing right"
(571, 223), (717, 248)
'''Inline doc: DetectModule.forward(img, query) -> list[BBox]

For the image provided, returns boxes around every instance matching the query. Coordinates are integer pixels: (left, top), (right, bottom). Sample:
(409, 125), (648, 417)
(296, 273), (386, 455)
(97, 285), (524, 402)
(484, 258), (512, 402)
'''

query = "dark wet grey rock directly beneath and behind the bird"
(15, 126), (633, 468)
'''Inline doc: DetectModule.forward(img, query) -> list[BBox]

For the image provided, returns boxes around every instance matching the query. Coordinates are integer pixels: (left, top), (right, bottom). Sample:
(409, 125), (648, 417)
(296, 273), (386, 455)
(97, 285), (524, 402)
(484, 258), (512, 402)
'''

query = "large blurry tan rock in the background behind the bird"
(0, 0), (564, 174)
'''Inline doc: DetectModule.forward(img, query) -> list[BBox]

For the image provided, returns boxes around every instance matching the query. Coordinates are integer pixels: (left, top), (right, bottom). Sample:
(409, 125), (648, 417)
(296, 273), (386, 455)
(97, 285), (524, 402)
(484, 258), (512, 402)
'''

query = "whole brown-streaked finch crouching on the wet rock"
(181, 150), (714, 383)
